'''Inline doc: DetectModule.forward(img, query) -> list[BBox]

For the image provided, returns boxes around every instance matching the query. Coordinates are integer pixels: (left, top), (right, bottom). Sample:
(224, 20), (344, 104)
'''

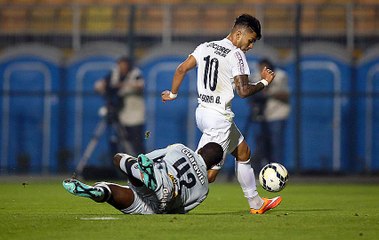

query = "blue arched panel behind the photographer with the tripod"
(62, 42), (127, 172)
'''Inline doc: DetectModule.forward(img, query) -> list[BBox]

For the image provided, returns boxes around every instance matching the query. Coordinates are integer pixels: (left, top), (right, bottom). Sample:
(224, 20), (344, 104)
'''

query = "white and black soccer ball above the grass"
(259, 163), (288, 192)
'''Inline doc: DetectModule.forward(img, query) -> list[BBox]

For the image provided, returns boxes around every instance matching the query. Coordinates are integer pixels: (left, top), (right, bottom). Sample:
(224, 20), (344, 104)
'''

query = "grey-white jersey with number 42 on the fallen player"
(146, 144), (208, 213)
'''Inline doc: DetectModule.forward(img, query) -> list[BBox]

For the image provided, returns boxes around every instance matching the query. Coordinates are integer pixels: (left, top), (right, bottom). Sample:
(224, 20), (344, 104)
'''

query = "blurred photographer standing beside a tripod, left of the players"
(94, 57), (145, 157)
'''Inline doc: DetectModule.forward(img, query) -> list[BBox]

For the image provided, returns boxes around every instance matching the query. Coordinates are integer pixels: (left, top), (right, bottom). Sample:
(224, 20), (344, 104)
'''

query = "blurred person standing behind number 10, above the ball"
(248, 58), (290, 169)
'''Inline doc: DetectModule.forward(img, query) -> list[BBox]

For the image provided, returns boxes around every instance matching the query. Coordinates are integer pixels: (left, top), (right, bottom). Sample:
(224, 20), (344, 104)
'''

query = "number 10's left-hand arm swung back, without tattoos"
(162, 55), (196, 102)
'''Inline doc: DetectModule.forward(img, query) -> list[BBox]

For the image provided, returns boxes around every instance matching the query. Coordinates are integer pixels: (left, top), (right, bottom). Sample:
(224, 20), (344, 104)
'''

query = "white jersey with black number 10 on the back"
(191, 38), (250, 117)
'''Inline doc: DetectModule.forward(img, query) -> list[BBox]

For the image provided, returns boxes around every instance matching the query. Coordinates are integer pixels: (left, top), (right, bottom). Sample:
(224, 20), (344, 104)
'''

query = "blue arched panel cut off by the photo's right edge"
(355, 45), (379, 172)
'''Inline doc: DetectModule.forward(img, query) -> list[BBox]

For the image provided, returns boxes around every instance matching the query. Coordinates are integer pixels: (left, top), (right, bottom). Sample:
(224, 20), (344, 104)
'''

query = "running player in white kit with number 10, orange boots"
(162, 14), (282, 214)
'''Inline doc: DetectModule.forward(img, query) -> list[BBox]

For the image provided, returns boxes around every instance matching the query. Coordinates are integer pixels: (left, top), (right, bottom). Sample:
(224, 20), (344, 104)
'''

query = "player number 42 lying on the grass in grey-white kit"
(63, 142), (224, 214)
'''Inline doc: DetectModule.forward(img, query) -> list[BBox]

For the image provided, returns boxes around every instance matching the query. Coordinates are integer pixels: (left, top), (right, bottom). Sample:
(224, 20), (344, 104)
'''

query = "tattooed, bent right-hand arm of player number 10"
(234, 65), (275, 98)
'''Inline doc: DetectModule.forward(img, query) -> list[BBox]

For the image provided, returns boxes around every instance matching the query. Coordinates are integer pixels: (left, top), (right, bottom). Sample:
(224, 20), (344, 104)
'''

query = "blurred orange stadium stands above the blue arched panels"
(0, 0), (379, 54)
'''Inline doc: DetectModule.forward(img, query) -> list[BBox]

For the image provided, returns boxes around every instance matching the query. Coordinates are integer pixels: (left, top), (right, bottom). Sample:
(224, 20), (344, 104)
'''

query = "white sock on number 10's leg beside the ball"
(236, 159), (264, 209)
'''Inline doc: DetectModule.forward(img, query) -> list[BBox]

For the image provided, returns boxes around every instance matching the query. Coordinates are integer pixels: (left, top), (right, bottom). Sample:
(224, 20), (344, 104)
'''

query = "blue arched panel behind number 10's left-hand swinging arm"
(140, 44), (199, 151)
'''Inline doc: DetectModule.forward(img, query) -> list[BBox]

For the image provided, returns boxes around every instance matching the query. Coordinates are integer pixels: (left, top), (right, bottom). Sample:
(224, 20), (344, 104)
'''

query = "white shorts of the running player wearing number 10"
(196, 107), (244, 170)
